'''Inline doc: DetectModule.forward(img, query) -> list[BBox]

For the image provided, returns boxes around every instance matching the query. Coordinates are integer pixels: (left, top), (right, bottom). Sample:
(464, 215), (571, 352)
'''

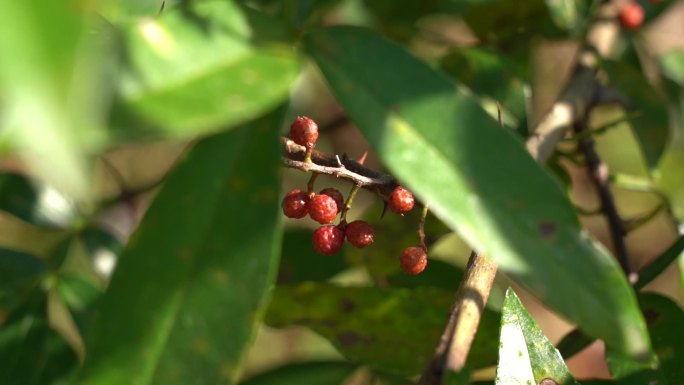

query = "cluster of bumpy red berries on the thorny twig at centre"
(282, 116), (427, 275)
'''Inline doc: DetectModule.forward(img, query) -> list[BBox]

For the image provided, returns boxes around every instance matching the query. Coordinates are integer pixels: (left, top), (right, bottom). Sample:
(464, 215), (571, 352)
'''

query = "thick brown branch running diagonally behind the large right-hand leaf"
(419, 1), (619, 385)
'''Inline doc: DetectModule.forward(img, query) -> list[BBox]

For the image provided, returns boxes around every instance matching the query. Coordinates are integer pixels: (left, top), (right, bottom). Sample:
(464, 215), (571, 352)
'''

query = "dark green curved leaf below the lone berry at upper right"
(601, 60), (670, 169)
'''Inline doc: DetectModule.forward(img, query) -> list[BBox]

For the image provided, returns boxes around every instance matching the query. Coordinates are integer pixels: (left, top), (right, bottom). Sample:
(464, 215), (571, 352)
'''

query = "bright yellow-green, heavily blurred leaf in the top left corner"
(0, 0), (110, 200)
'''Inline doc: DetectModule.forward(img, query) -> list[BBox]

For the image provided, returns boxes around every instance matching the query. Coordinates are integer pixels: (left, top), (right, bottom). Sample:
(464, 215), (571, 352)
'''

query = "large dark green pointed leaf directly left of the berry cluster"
(80, 109), (282, 384)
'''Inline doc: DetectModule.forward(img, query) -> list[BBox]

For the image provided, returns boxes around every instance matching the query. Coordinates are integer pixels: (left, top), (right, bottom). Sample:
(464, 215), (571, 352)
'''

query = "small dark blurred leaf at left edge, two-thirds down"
(0, 249), (47, 314)
